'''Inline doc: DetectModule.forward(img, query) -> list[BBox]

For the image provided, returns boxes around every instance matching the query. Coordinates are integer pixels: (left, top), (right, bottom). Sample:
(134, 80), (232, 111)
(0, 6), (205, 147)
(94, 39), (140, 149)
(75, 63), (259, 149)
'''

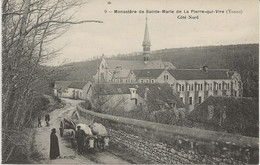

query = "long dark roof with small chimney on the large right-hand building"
(168, 69), (234, 80)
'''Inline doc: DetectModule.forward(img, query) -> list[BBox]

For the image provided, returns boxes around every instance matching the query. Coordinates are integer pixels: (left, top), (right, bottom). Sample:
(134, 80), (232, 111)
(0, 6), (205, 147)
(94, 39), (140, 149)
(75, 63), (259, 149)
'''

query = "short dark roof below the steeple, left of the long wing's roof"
(133, 69), (164, 78)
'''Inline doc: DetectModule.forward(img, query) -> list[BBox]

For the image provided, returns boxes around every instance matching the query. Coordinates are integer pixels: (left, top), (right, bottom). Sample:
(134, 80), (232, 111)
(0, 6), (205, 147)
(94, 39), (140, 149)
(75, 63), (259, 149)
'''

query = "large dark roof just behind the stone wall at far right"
(188, 96), (259, 136)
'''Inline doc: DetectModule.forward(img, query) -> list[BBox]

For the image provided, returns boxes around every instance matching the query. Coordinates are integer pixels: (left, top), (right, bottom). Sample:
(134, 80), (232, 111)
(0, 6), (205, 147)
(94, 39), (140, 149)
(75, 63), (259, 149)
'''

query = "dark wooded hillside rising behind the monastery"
(62, 44), (259, 97)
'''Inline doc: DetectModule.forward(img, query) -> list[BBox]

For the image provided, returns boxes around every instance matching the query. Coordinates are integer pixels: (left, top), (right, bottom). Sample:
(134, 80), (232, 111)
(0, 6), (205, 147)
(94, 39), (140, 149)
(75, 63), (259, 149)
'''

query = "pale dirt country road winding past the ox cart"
(33, 99), (130, 164)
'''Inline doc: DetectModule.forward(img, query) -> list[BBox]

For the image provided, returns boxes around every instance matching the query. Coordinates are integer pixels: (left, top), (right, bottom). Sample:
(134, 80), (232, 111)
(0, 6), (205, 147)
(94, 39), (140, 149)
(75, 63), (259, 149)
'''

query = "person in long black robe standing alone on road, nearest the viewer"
(50, 128), (60, 159)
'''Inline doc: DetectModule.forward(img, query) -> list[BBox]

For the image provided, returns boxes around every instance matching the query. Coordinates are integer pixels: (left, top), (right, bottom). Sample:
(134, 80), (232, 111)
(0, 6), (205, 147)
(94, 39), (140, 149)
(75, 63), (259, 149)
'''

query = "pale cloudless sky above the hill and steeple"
(48, 0), (259, 65)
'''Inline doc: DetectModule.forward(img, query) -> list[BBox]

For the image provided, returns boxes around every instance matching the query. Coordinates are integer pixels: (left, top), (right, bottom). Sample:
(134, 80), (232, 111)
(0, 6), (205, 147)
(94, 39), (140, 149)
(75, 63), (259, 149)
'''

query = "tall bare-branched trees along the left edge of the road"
(2, 0), (102, 162)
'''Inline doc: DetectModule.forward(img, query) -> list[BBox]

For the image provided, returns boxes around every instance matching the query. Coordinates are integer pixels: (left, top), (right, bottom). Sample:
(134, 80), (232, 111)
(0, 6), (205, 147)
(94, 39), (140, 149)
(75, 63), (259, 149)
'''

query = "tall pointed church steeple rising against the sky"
(143, 17), (151, 63)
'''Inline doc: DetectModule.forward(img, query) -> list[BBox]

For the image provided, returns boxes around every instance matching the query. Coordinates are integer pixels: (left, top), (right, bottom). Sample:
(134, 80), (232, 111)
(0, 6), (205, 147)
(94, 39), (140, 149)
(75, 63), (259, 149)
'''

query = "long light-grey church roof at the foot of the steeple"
(106, 59), (165, 70)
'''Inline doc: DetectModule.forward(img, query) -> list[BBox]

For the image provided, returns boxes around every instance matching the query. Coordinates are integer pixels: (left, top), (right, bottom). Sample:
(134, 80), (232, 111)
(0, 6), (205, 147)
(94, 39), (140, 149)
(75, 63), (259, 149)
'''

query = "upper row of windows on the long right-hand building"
(177, 83), (230, 91)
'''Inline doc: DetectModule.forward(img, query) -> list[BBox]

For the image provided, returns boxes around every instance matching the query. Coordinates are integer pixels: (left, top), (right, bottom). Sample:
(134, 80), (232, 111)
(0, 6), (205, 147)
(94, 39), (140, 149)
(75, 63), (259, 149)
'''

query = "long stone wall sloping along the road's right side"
(77, 106), (258, 164)
